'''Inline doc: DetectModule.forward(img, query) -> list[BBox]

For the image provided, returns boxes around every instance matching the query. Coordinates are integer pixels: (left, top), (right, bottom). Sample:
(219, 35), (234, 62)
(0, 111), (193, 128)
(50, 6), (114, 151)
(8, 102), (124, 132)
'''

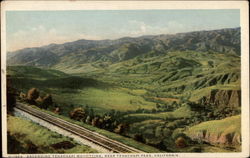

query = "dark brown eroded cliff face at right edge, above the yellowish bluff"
(201, 89), (241, 107)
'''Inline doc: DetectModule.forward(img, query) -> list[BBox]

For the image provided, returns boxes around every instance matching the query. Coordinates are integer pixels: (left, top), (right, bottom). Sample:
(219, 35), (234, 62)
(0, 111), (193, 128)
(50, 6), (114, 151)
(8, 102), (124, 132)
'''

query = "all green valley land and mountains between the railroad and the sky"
(7, 28), (241, 152)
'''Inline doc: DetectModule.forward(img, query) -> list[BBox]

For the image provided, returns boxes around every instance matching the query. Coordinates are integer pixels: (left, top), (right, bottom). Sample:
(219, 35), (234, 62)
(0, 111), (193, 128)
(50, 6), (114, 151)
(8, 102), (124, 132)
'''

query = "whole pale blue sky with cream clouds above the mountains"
(6, 9), (240, 51)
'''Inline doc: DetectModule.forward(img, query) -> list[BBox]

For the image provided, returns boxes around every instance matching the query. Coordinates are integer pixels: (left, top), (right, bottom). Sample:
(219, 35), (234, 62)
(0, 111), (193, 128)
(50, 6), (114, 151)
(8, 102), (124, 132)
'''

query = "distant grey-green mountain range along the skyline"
(7, 28), (240, 70)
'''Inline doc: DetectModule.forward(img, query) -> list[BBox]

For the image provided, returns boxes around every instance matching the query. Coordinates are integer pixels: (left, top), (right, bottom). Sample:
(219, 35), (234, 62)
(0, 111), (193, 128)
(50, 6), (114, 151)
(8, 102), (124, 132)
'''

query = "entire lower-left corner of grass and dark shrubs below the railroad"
(7, 115), (98, 154)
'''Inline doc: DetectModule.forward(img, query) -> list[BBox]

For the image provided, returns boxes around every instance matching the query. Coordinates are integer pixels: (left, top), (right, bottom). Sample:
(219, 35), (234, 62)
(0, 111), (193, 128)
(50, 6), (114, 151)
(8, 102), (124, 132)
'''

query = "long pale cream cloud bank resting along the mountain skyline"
(7, 20), (187, 51)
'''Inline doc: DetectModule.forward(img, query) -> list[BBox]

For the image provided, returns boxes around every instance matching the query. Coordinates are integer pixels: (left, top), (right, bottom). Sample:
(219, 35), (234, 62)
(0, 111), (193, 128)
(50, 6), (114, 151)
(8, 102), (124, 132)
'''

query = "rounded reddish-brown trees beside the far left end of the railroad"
(19, 88), (54, 109)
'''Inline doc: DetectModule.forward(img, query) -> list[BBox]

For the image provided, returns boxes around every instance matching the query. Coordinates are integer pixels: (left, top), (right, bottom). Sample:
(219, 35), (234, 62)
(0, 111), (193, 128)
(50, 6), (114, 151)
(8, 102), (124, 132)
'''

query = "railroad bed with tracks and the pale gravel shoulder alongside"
(15, 103), (141, 153)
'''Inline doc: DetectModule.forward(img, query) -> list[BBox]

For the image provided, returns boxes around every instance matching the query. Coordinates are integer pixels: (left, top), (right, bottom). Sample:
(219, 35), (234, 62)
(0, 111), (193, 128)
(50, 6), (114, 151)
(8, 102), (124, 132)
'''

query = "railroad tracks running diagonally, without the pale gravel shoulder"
(16, 102), (143, 153)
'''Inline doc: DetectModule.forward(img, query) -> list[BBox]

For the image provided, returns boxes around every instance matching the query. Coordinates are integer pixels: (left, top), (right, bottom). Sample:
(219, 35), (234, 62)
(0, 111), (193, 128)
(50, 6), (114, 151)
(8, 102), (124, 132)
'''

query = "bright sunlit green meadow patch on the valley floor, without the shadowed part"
(53, 88), (155, 111)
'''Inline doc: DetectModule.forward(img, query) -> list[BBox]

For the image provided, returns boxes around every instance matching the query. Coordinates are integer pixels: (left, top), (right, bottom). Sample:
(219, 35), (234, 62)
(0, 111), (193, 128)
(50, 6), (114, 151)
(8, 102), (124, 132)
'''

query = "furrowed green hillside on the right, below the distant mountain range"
(80, 51), (240, 101)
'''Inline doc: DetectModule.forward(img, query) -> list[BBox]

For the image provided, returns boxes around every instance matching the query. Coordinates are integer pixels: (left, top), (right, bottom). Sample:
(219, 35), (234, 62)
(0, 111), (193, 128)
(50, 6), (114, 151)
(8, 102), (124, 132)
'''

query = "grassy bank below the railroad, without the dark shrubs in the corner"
(7, 115), (97, 153)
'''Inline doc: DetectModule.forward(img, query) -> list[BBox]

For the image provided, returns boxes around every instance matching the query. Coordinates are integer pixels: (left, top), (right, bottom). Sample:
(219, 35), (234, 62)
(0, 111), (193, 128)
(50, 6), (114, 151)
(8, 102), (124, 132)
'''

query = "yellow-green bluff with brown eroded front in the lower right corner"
(186, 115), (241, 146)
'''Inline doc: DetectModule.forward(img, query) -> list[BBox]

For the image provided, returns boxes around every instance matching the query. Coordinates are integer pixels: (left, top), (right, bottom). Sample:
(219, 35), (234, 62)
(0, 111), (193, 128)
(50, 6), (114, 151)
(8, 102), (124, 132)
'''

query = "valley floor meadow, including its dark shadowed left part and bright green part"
(8, 66), (155, 114)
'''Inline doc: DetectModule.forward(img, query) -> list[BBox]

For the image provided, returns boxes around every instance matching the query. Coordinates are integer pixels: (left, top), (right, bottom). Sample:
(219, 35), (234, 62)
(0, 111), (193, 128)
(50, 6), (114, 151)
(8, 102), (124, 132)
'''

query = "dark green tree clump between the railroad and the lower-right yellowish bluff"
(126, 119), (197, 152)
